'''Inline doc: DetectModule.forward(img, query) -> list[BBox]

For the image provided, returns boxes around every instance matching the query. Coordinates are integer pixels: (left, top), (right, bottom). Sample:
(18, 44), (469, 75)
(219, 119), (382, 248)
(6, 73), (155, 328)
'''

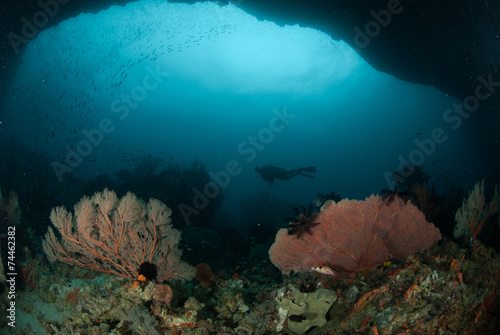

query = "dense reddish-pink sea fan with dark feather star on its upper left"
(269, 196), (441, 274)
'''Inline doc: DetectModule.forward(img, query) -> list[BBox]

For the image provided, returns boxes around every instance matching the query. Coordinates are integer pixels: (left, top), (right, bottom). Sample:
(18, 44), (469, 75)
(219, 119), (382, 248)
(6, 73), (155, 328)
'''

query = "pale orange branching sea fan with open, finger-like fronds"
(43, 189), (195, 282)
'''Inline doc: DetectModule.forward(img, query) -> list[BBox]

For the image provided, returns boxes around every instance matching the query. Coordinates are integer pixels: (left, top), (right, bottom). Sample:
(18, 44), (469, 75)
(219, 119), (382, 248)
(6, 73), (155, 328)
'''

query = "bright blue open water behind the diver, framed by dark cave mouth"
(3, 0), (476, 218)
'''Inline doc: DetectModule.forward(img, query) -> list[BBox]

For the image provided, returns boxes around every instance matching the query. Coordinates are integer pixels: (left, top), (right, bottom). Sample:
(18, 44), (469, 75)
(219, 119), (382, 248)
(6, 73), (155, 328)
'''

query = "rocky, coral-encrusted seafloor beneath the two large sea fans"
(0, 241), (500, 335)
